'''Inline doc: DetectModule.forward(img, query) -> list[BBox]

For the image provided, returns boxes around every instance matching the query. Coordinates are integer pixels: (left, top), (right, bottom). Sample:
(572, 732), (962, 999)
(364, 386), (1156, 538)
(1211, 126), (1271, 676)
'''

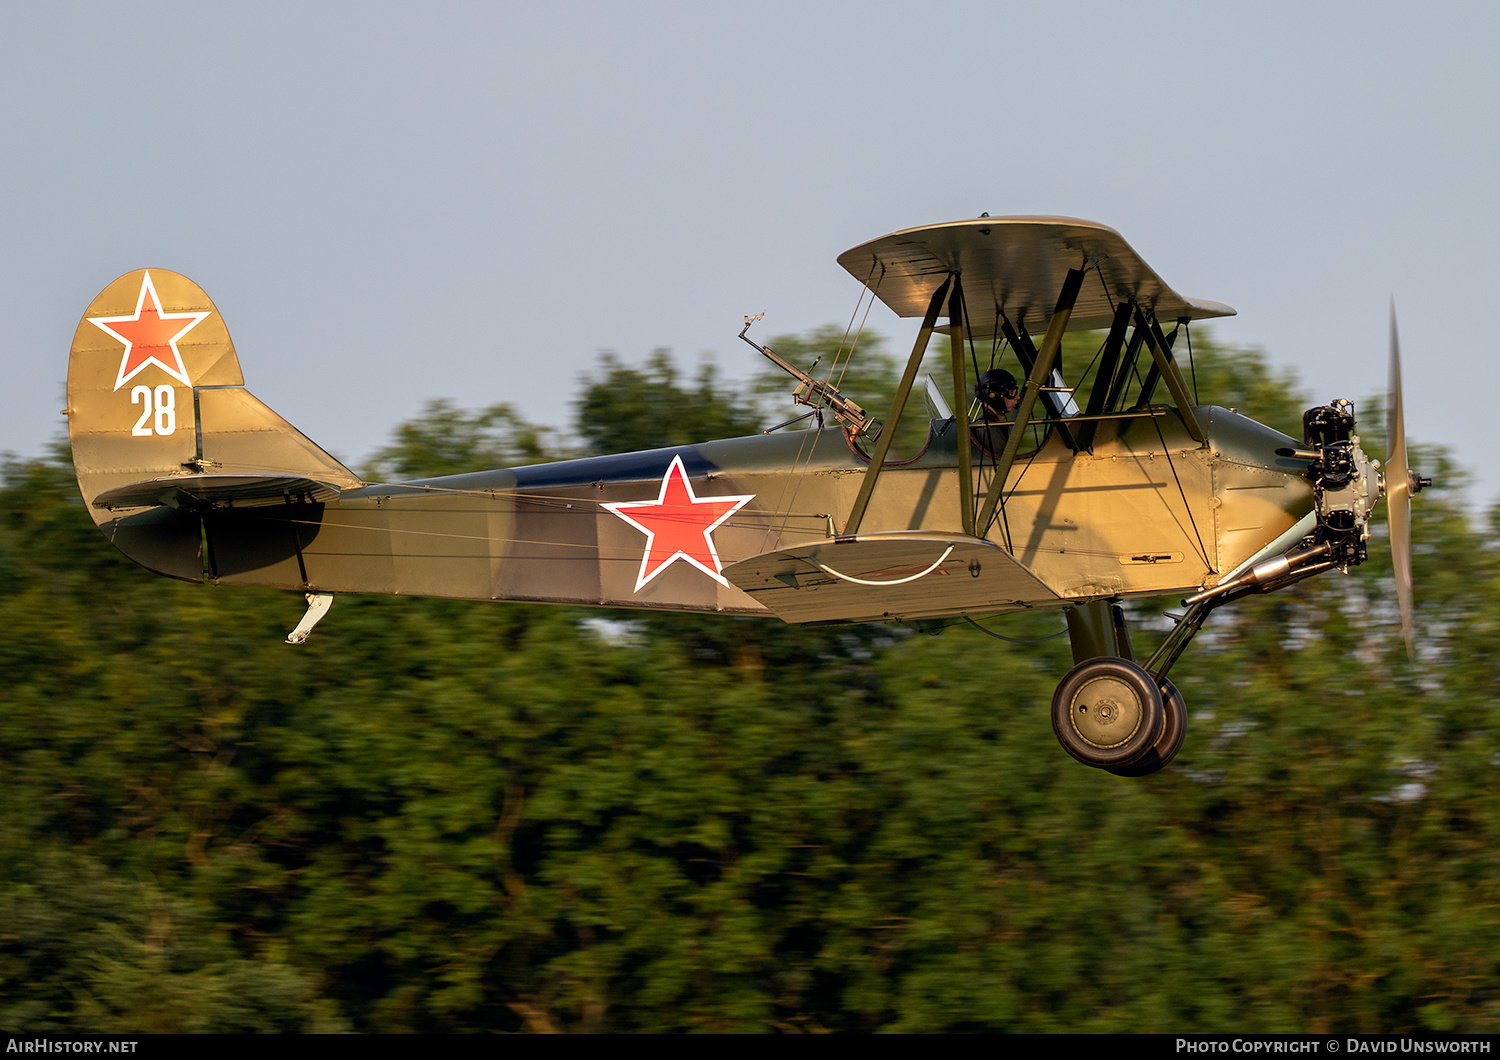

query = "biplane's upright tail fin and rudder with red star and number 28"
(68, 268), (362, 582)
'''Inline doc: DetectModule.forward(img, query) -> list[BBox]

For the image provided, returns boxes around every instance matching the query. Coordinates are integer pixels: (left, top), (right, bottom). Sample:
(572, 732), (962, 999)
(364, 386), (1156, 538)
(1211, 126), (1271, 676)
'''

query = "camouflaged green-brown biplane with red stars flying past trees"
(66, 216), (1427, 777)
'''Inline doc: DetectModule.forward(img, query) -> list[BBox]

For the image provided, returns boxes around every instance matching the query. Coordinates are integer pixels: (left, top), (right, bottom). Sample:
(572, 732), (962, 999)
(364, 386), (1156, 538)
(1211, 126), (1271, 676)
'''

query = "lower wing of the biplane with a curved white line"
(725, 532), (1058, 622)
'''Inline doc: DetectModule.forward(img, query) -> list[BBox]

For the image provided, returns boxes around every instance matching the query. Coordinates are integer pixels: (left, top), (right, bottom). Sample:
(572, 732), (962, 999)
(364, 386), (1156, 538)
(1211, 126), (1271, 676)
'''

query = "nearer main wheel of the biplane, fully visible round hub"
(1052, 658), (1166, 769)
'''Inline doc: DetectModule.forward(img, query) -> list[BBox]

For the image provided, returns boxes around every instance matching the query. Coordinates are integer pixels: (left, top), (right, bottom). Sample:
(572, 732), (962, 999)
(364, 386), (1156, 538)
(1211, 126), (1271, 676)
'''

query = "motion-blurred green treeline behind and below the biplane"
(0, 331), (1500, 1033)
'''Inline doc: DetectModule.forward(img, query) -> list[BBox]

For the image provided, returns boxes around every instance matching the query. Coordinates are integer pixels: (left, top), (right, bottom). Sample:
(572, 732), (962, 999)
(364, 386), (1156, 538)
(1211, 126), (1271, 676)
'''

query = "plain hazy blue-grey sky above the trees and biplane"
(0, 0), (1500, 505)
